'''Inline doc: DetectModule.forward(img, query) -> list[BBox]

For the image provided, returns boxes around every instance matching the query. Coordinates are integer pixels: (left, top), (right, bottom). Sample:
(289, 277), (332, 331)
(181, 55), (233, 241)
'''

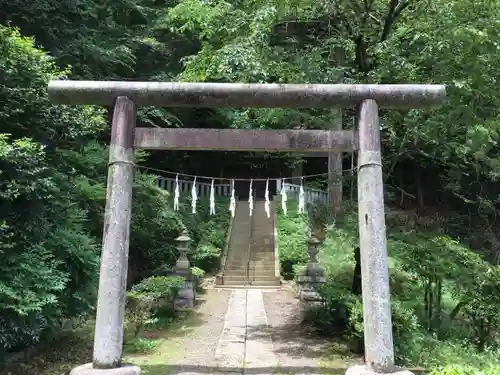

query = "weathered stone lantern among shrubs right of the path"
(297, 237), (326, 305)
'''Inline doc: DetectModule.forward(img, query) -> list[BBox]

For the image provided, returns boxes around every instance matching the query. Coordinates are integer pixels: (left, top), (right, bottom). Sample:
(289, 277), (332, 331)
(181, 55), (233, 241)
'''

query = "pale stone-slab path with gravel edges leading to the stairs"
(133, 288), (358, 375)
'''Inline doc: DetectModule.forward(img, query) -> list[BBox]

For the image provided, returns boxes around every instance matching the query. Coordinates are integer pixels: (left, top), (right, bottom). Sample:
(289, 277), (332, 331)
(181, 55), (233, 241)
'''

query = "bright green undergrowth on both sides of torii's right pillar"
(278, 203), (500, 375)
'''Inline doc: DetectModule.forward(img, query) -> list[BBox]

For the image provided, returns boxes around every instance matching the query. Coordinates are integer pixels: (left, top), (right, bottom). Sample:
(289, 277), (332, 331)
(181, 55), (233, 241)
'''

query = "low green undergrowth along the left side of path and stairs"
(0, 198), (230, 375)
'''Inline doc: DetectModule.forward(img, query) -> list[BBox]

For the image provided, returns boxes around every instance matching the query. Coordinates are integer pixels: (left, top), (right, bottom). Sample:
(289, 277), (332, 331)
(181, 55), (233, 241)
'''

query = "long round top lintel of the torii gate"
(48, 80), (446, 108)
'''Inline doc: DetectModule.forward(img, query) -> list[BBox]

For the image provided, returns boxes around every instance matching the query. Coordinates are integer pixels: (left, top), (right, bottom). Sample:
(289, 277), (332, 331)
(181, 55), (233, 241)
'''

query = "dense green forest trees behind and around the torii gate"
(0, 0), (500, 374)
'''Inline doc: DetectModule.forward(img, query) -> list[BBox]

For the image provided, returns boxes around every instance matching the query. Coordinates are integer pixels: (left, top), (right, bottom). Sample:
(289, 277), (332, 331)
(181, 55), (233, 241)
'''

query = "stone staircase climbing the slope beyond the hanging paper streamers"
(218, 201), (281, 287)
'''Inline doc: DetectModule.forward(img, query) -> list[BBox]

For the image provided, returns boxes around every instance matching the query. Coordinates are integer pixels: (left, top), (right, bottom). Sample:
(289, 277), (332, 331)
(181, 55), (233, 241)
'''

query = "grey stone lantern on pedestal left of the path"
(174, 231), (196, 309)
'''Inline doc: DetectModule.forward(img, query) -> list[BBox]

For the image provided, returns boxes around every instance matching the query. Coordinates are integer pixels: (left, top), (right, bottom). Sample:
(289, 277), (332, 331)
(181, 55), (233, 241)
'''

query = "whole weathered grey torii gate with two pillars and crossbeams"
(48, 81), (446, 375)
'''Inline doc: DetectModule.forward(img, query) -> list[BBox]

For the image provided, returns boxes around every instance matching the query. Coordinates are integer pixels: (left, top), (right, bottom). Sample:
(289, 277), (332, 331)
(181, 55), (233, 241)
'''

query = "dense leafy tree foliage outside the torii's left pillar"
(0, 26), (104, 356)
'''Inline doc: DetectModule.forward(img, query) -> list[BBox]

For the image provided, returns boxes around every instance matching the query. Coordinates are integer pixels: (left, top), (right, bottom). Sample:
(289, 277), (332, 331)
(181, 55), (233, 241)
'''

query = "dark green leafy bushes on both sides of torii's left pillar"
(0, 24), (227, 355)
